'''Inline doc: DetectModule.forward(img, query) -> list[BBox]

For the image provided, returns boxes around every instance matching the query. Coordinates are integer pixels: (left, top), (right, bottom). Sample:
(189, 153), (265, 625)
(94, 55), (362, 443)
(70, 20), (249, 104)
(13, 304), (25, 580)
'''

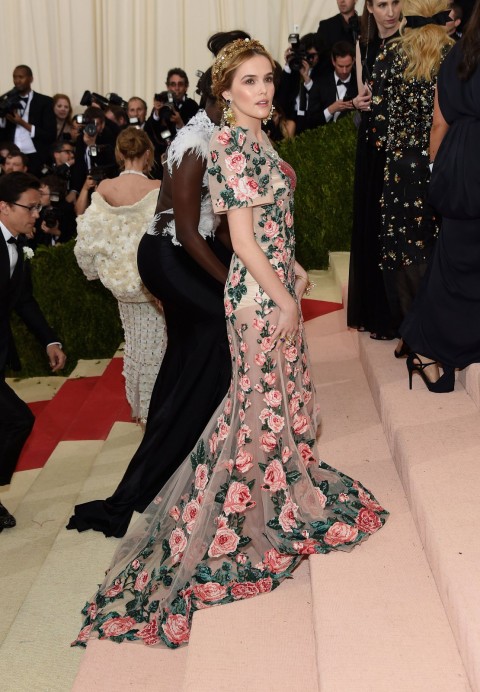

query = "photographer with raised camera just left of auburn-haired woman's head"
(70, 106), (118, 200)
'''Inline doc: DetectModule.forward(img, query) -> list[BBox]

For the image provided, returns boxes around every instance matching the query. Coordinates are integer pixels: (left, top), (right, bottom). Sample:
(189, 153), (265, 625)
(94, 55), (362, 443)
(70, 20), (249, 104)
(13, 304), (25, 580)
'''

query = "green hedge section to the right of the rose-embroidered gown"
(278, 116), (357, 269)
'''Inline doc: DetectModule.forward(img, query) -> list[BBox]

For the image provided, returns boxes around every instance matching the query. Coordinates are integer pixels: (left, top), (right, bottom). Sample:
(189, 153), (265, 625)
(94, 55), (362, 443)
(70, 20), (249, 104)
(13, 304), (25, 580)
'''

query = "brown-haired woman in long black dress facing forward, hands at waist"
(347, 0), (401, 339)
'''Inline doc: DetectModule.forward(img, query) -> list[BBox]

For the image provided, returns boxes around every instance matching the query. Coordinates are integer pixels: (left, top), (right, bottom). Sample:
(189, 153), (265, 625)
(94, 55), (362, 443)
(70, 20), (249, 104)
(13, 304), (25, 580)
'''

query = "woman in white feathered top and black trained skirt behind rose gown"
(67, 32), (251, 538)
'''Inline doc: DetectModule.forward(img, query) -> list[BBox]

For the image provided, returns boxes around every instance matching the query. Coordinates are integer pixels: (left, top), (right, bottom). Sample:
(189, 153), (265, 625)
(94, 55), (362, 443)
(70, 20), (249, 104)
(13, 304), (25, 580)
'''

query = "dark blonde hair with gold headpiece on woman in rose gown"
(212, 38), (275, 108)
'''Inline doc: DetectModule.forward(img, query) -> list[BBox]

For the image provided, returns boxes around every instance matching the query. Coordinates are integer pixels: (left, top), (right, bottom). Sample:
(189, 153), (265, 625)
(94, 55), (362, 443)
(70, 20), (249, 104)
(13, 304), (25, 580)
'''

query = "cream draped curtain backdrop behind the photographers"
(0, 0), (350, 110)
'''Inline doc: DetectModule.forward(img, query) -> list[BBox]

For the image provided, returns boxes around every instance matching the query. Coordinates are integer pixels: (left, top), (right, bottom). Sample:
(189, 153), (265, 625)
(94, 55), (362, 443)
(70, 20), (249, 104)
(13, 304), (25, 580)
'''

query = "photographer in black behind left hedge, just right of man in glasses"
(28, 175), (77, 250)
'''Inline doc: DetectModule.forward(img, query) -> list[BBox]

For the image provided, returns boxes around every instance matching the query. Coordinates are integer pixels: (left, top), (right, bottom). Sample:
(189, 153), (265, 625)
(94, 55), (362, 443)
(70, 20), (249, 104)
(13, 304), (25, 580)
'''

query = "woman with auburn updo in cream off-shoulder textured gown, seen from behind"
(75, 127), (167, 421)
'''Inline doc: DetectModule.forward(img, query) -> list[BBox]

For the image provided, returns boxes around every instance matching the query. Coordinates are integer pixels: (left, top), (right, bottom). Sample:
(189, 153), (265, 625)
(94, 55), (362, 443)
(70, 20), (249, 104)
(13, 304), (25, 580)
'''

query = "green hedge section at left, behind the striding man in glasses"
(7, 240), (123, 377)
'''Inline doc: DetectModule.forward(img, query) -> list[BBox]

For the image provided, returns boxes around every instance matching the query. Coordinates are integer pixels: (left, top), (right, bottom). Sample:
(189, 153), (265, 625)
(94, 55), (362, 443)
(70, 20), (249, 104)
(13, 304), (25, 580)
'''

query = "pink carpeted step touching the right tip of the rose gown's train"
(308, 324), (469, 692)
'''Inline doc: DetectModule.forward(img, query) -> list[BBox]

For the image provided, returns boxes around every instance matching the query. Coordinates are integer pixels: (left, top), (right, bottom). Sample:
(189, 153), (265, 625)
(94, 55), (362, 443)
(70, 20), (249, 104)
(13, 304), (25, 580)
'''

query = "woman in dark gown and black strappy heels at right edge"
(400, 1), (480, 392)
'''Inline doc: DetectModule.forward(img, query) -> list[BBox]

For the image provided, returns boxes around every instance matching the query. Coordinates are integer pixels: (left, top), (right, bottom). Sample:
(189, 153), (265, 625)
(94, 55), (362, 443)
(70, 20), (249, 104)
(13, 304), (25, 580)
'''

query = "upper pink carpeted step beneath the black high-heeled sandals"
(359, 335), (480, 690)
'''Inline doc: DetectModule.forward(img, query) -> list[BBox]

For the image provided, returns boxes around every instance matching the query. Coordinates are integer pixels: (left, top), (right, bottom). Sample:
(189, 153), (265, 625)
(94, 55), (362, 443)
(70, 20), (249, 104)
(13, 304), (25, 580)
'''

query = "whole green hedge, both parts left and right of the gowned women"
(9, 117), (356, 377)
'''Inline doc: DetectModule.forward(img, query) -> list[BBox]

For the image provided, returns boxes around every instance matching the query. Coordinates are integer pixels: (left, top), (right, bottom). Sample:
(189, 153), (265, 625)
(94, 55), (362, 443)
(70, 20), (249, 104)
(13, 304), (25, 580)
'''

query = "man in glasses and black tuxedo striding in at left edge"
(0, 173), (65, 532)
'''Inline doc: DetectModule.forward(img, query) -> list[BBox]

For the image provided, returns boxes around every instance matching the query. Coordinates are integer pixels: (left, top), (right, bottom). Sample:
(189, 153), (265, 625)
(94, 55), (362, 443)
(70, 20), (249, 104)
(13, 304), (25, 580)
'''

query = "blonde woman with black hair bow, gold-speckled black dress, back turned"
(380, 0), (453, 358)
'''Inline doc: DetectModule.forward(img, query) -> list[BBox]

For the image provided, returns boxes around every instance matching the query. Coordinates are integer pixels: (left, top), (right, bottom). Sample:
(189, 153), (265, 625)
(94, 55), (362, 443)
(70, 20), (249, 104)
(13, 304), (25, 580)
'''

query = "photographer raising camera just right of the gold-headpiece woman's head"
(277, 34), (320, 134)
